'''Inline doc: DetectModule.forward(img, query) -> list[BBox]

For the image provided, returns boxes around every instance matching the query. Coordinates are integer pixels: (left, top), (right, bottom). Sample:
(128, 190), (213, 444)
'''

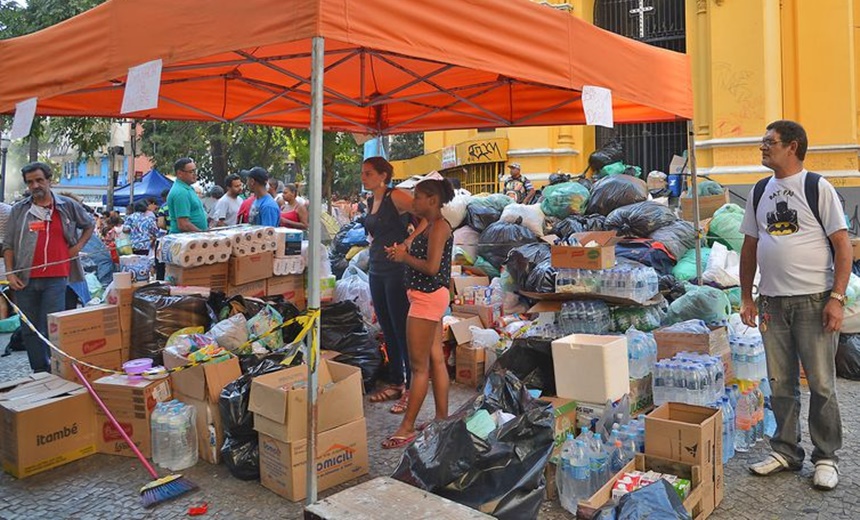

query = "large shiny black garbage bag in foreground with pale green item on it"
(392, 369), (554, 520)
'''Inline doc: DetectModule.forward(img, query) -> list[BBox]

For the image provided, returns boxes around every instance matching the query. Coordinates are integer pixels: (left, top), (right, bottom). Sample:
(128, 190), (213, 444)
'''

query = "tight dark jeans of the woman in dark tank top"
(370, 269), (412, 388)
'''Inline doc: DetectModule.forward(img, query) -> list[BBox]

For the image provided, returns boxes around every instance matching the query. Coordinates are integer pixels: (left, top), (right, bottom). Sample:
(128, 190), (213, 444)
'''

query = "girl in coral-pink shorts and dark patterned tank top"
(382, 179), (454, 449)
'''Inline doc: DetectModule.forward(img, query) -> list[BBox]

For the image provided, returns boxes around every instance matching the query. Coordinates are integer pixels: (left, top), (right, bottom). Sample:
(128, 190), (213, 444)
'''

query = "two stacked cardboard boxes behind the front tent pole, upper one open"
(248, 359), (368, 501)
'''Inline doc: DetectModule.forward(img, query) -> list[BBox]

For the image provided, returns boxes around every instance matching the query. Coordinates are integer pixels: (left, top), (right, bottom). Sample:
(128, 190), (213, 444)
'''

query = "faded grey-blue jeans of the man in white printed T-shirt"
(759, 292), (842, 468)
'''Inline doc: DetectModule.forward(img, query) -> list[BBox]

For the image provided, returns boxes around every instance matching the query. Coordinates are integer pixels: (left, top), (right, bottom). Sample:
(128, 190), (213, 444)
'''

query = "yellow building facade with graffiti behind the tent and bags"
(395, 0), (860, 191)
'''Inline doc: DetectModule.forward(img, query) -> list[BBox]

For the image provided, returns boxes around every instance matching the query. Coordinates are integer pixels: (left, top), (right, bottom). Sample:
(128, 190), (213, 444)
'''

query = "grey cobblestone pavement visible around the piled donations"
(0, 335), (860, 520)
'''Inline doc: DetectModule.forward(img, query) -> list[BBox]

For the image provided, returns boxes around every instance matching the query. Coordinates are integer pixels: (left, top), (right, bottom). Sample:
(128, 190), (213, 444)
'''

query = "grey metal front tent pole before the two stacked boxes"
(305, 36), (325, 505)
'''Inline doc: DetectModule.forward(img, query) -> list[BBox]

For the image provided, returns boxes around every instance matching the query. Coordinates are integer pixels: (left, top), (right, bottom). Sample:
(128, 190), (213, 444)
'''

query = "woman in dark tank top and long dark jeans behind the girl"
(361, 157), (423, 413)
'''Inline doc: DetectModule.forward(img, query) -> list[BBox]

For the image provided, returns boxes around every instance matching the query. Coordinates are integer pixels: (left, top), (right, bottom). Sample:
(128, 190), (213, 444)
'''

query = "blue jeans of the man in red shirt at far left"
(15, 277), (68, 372)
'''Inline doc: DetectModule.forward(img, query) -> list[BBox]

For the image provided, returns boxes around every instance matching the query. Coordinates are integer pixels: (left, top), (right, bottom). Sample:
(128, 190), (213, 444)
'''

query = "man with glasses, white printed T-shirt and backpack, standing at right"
(740, 120), (851, 490)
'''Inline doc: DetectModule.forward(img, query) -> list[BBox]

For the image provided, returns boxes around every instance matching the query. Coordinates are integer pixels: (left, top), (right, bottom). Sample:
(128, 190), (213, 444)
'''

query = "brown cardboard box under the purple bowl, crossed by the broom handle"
(93, 374), (173, 457)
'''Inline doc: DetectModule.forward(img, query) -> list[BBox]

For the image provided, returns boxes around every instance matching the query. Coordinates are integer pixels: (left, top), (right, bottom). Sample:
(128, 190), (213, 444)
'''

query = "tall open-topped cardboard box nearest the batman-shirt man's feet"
(645, 403), (725, 516)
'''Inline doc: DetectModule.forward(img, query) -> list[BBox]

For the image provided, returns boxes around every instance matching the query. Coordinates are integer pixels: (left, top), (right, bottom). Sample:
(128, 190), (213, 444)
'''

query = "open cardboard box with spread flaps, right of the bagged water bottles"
(164, 350), (242, 464)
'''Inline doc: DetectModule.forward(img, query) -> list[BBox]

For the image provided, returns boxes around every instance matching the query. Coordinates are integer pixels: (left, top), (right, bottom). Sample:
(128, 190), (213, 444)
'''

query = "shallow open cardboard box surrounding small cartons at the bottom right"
(576, 454), (707, 520)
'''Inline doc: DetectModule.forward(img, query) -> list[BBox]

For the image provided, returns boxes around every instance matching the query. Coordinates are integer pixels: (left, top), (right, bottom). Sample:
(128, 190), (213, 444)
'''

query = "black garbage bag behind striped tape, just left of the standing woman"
(320, 300), (382, 388)
